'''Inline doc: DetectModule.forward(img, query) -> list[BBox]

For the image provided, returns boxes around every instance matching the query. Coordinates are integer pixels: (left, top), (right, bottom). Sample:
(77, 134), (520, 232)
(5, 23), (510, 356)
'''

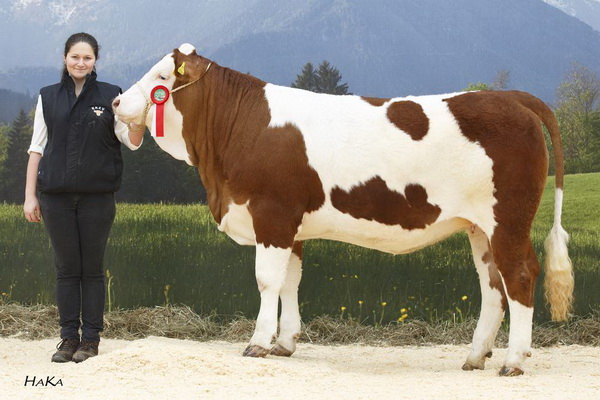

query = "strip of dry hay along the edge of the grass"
(0, 303), (600, 347)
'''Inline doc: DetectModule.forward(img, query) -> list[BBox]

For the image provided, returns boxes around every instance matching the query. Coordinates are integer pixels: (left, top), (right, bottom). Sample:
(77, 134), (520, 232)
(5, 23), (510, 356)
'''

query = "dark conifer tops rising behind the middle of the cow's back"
(292, 60), (349, 95)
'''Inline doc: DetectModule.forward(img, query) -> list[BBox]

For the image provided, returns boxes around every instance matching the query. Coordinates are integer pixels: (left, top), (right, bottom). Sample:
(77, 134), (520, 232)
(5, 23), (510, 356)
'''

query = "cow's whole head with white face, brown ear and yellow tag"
(113, 43), (206, 165)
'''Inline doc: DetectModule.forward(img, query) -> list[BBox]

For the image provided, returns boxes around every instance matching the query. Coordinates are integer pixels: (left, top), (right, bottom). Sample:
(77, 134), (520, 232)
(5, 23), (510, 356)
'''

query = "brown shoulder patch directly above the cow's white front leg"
(239, 124), (325, 248)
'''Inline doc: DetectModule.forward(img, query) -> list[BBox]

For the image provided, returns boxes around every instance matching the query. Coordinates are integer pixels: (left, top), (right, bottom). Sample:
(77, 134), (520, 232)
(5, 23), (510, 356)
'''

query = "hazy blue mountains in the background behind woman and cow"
(0, 0), (600, 108)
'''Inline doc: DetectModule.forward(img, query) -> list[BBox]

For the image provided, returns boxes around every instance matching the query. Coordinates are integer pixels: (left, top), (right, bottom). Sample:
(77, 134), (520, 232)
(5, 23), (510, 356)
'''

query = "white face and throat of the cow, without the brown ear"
(115, 53), (192, 165)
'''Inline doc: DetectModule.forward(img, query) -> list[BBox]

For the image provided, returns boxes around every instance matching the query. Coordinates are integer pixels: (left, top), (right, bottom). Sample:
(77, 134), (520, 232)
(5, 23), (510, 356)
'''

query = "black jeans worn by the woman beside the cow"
(40, 193), (115, 342)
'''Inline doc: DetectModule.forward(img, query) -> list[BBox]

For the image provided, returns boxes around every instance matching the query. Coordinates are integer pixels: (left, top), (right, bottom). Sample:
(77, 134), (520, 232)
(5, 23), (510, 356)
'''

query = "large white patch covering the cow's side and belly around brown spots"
(265, 84), (496, 253)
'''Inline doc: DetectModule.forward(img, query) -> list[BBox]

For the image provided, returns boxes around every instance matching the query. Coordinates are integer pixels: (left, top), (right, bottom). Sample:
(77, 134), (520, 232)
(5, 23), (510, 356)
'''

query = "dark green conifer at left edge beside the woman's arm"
(0, 110), (33, 203)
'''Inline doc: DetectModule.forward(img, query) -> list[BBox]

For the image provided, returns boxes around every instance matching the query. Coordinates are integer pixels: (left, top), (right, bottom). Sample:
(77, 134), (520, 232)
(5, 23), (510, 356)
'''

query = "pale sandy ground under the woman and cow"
(0, 337), (600, 400)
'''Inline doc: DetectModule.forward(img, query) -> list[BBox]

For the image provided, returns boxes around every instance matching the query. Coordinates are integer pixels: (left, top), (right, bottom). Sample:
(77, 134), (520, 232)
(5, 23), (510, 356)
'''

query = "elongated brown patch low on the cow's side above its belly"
(331, 176), (441, 230)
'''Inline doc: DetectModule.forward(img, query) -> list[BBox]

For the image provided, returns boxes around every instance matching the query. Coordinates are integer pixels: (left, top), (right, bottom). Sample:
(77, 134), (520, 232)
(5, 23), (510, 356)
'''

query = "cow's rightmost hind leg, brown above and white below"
(492, 232), (540, 376)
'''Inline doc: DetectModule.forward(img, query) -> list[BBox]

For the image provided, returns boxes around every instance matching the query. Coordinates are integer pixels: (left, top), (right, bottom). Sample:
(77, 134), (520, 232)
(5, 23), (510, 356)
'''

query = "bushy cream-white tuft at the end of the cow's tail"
(544, 220), (574, 321)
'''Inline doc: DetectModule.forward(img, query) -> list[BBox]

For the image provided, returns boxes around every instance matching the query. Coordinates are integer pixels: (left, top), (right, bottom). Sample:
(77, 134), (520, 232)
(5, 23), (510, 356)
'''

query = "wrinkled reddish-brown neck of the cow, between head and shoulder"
(178, 65), (270, 223)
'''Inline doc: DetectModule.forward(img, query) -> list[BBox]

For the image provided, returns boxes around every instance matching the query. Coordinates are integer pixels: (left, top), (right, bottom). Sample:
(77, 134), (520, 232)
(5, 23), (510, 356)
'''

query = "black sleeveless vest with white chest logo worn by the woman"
(38, 72), (123, 193)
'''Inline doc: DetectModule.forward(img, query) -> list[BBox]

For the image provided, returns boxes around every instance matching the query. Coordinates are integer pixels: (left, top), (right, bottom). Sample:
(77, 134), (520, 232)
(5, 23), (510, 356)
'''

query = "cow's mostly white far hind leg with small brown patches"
(462, 225), (506, 371)
